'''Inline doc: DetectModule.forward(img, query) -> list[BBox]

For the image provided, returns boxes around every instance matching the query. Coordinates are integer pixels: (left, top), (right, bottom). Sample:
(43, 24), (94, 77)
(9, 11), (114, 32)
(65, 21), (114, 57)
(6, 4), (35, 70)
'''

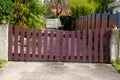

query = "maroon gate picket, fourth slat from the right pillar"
(88, 29), (93, 62)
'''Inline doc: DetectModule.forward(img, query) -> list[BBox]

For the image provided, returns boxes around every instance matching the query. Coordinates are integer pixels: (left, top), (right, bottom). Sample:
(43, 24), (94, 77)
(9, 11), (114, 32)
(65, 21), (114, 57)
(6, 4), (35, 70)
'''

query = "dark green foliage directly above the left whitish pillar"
(0, 0), (14, 23)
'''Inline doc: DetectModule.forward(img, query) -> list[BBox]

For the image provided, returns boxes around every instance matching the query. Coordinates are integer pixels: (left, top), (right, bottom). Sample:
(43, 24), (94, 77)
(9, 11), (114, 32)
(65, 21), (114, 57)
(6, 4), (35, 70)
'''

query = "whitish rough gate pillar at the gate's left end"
(0, 24), (8, 61)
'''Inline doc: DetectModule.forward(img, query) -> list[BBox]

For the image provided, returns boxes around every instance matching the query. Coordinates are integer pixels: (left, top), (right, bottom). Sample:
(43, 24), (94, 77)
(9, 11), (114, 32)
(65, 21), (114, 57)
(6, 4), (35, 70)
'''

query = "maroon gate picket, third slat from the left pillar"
(20, 27), (25, 61)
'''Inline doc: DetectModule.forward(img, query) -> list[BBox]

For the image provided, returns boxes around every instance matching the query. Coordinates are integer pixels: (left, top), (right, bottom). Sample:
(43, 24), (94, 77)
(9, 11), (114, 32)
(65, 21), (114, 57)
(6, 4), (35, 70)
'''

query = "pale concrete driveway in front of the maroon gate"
(0, 62), (120, 80)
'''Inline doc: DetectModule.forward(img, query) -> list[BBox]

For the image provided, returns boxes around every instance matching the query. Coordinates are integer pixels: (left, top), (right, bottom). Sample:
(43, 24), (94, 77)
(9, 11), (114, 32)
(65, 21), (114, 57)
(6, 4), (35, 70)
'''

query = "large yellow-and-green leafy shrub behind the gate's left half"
(11, 0), (47, 29)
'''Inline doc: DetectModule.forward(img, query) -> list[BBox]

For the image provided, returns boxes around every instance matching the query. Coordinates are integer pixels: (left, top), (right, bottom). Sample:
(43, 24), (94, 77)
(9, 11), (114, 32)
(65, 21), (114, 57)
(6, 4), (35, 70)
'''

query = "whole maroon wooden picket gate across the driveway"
(8, 25), (111, 63)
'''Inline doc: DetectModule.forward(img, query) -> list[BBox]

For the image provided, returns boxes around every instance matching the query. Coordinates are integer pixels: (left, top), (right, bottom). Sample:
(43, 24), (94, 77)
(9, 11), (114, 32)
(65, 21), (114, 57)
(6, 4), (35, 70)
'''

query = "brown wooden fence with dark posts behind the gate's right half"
(75, 13), (120, 30)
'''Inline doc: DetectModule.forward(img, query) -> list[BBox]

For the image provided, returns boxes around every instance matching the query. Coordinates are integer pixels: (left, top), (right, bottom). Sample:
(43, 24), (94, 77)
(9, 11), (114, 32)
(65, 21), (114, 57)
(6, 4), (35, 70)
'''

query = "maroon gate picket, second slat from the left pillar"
(14, 26), (18, 61)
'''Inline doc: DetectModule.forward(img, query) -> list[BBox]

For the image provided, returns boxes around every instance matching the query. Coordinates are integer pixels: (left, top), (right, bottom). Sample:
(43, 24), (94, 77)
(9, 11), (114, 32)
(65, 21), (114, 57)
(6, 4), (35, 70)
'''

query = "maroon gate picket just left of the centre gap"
(55, 31), (60, 61)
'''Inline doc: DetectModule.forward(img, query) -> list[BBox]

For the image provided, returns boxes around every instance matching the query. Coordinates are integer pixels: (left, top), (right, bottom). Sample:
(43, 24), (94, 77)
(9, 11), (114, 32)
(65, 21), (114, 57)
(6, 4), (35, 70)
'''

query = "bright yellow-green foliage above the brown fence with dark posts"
(69, 0), (114, 17)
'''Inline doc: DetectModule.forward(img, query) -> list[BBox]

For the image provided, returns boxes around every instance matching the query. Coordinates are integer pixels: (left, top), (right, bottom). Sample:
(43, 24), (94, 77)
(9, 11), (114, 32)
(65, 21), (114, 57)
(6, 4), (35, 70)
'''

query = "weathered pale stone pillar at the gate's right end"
(110, 29), (120, 62)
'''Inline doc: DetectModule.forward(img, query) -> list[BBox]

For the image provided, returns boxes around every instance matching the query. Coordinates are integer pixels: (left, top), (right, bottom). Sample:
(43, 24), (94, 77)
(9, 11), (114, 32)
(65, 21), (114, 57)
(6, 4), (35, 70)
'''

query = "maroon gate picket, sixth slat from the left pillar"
(38, 30), (42, 60)
